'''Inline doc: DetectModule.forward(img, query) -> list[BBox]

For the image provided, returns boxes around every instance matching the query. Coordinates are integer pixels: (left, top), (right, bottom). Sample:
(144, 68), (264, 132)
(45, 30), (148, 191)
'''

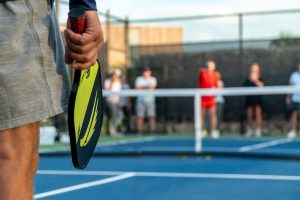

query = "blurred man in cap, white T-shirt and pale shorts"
(135, 67), (157, 133)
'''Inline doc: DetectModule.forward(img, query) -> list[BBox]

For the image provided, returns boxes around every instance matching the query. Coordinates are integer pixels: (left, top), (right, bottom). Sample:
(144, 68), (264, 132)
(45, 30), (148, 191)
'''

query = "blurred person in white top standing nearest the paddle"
(104, 70), (122, 136)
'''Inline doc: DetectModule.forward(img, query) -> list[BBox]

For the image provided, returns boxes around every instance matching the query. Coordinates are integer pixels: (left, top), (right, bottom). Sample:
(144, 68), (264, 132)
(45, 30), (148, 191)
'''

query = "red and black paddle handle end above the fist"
(69, 9), (85, 34)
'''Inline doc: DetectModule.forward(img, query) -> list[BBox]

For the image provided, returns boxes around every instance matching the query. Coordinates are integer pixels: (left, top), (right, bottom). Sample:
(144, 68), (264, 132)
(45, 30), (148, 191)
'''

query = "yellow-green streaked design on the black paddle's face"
(74, 62), (100, 147)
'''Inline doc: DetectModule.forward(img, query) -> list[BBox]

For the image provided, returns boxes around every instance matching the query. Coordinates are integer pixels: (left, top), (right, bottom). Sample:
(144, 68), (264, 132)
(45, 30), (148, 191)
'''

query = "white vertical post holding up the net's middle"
(194, 93), (202, 153)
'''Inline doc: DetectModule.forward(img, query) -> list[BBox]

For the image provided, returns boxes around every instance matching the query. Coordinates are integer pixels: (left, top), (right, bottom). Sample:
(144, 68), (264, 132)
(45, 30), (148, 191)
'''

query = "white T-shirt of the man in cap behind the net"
(135, 76), (157, 103)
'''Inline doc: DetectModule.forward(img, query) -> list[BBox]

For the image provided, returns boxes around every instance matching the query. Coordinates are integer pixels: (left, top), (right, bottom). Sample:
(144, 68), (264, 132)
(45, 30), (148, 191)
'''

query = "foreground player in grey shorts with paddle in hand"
(0, 0), (103, 200)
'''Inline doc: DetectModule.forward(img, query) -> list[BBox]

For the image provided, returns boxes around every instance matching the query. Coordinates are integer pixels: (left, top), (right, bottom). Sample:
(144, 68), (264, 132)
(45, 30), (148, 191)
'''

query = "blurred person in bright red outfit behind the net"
(198, 60), (220, 139)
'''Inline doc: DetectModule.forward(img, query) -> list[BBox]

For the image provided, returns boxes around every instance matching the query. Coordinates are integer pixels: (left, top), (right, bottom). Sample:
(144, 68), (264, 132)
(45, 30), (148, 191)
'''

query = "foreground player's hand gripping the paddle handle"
(64, 11), (104, 70)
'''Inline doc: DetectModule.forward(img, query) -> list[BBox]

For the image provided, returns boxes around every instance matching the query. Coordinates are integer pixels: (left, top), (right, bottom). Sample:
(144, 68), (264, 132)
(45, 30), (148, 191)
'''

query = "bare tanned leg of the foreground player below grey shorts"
(0, 123), (39, 200)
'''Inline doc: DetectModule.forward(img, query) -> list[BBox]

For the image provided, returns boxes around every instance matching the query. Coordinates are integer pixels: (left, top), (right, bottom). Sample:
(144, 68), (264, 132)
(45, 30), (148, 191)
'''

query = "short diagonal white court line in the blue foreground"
(34, 172), (135, 199)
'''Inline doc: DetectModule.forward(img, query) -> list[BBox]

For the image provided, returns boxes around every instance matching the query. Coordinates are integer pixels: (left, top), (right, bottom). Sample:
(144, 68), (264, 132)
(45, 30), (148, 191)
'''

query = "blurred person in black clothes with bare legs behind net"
(244, 63), (265, 137)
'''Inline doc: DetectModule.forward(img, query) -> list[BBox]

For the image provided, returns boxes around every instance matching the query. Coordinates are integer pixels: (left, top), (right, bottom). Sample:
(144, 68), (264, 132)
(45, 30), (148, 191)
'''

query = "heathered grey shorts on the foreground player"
(0, 0), (70, 130)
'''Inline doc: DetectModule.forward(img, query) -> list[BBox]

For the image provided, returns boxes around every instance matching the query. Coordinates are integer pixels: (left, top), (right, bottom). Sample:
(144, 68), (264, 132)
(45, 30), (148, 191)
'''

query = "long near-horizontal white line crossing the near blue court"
(38, 170), (300, 181)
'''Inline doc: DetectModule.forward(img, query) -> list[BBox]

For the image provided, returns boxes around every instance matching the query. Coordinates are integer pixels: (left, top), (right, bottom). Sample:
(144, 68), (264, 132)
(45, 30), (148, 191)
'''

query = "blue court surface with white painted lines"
(35, 137), (300, 200)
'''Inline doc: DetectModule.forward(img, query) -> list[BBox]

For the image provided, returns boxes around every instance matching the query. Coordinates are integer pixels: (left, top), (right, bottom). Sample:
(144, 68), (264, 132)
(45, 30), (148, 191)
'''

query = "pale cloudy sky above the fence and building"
(59, 0), (300, 42)
